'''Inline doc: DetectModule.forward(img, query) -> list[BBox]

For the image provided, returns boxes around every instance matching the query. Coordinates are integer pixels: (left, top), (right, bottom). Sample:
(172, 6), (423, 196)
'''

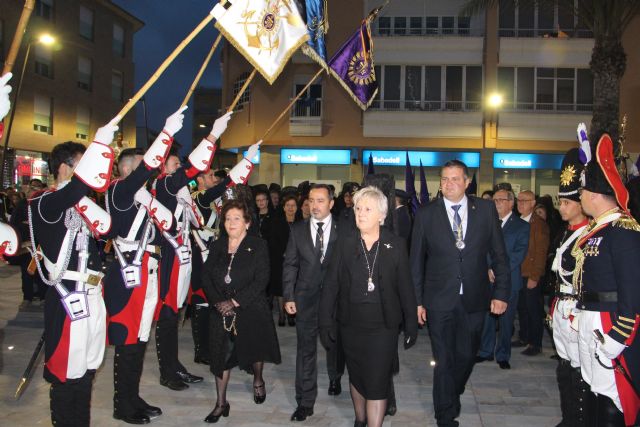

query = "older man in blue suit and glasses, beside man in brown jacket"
(476, 190), (529, 369)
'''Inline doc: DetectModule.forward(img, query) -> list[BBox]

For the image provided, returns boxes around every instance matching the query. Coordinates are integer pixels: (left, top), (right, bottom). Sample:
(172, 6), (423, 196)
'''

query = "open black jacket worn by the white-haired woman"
(319, 227), (418, 338)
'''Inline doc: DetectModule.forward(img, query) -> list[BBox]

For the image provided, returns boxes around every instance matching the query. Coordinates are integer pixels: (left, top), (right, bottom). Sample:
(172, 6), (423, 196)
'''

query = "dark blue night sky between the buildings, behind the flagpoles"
(112, 0), (222, 152)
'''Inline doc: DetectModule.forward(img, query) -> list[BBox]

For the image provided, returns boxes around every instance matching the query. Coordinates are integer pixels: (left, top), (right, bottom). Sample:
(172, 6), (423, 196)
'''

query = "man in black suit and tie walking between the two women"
(282, 184), (344, 421)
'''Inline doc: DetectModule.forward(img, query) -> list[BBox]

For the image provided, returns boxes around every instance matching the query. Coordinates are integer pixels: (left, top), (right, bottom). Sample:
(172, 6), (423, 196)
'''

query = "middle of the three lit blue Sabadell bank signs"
(362, 150), (480, 168)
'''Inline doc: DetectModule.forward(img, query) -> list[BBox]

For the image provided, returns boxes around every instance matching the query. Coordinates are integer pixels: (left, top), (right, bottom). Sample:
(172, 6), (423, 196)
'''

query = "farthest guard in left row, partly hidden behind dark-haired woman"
(189, 169), (231, 365)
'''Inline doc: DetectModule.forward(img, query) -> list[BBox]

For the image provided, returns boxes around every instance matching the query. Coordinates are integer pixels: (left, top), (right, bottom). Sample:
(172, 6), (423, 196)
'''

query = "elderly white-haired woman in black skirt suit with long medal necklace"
(319, 186), (418, 427)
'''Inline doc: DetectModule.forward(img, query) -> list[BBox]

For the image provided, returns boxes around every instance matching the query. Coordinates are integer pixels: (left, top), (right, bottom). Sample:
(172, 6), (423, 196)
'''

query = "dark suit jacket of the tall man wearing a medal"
(411, 197), (511, 312)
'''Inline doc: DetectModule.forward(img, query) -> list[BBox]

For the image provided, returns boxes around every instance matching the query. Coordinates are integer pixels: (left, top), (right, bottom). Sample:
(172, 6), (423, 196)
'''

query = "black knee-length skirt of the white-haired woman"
(340, 304), (398, 400)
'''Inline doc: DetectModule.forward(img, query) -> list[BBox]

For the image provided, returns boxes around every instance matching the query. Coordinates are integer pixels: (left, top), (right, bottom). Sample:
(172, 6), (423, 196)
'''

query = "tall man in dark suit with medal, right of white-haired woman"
(411, 160), (511, 426)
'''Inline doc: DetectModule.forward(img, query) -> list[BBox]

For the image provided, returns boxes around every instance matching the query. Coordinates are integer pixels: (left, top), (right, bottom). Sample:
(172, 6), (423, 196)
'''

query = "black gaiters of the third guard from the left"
(156, 310), (186, 380)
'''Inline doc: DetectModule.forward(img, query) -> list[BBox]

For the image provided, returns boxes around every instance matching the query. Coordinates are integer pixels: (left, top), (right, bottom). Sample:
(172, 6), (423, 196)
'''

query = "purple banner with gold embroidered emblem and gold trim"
(329, 19), (378, 110)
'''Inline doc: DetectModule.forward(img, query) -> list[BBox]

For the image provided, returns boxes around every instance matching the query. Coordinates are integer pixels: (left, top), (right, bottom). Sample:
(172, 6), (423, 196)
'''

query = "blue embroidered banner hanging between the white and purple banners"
(296, 0), (329, 70)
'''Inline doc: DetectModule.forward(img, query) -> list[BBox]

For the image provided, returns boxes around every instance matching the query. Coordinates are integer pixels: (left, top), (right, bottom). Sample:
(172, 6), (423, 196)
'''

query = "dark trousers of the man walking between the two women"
(296, 320), (345, 408)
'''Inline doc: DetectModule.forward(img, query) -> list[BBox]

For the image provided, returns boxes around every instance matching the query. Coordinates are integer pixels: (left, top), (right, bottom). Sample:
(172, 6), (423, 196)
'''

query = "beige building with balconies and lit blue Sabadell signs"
(222, 0), (640, 194)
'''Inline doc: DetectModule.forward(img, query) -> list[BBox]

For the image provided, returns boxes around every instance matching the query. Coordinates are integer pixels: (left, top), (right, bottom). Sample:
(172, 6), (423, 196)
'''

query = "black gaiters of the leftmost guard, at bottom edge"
(49, 371), (95, 427)
